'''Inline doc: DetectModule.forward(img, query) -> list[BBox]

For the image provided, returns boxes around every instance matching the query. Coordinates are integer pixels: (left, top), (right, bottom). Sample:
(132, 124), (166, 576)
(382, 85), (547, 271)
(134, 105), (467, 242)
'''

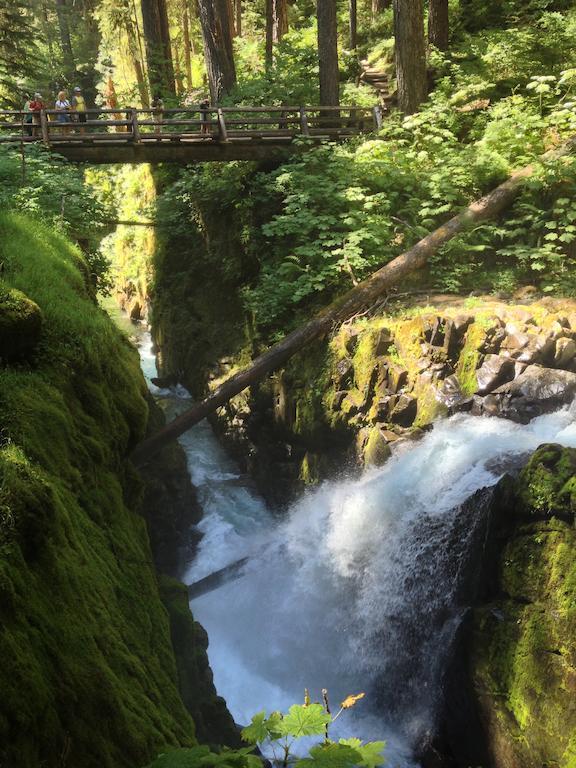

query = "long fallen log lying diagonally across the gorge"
(131, 136), (576, 467)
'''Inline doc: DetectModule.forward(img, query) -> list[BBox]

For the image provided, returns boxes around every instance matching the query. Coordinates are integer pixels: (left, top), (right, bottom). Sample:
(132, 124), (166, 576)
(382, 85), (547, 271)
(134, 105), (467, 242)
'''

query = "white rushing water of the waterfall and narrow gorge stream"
(132, 328), (576, 768)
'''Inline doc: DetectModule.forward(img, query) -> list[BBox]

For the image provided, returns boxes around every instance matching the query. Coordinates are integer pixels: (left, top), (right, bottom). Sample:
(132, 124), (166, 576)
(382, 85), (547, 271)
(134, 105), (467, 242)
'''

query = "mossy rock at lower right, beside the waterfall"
(472, 446), (576, 768)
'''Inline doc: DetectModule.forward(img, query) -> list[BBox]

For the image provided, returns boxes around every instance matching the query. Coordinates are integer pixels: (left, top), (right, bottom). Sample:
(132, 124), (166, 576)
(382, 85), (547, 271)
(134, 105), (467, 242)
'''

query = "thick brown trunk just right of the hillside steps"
(394, 0), (427, 115)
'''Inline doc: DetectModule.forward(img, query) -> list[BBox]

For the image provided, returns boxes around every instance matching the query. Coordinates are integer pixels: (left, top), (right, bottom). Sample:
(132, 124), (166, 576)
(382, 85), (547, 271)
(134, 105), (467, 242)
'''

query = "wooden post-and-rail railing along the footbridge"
(0, 105), (382, 146)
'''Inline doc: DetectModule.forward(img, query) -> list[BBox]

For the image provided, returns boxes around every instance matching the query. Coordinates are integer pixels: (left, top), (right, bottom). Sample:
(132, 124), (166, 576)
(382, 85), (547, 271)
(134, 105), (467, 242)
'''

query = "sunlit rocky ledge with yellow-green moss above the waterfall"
(212, 296), (576, 503)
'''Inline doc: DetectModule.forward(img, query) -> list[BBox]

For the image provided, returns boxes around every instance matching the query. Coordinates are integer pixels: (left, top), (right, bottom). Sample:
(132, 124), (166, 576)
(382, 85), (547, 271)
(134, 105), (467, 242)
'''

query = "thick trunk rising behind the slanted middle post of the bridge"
(198, 0), (236, 104)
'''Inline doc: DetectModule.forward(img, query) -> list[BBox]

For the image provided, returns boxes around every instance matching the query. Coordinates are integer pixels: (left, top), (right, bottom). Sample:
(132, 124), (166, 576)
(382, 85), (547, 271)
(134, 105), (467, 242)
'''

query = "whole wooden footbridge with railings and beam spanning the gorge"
(0, 106), (382, 163)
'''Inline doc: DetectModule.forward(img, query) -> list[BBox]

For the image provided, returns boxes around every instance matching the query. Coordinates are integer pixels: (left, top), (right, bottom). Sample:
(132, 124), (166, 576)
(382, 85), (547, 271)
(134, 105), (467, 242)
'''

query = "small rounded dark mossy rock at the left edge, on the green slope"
(0, 282), (42, 360)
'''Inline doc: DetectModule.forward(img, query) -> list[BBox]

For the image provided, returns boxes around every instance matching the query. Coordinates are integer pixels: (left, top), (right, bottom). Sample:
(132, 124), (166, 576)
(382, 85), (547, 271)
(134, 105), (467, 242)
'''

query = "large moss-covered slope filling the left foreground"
(0, 214), (195, 768)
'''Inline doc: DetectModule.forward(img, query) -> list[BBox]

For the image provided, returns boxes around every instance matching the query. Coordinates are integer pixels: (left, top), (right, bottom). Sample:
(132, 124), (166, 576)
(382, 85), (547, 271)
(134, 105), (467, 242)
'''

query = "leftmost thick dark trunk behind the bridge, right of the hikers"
(140, 0), (176, 98)
